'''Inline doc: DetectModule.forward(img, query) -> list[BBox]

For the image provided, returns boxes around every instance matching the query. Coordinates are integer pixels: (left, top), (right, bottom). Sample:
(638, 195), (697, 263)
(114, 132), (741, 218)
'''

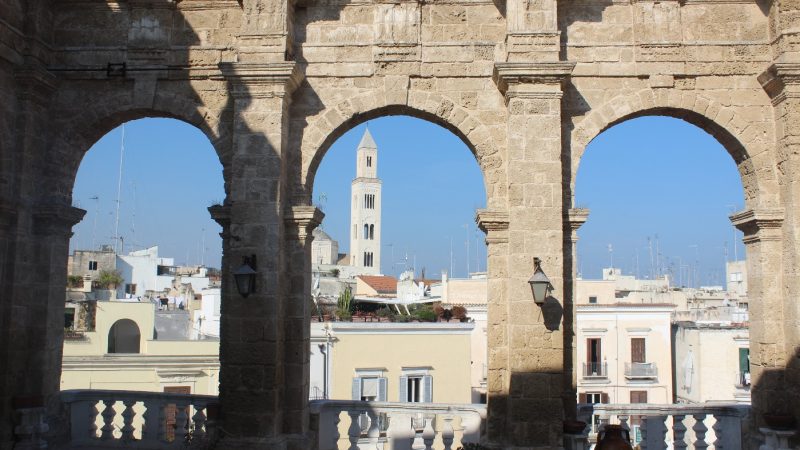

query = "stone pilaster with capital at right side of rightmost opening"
(731, 209), (797, 424)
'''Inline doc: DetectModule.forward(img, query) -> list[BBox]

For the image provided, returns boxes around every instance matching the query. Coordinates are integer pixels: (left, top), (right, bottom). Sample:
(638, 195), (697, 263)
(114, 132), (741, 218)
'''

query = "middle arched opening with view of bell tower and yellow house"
(308, 116), (487, 410)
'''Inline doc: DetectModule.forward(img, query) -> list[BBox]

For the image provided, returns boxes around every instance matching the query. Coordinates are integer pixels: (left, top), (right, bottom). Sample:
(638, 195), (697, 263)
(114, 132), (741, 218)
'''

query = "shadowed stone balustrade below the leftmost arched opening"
(61, 390), (217, 449)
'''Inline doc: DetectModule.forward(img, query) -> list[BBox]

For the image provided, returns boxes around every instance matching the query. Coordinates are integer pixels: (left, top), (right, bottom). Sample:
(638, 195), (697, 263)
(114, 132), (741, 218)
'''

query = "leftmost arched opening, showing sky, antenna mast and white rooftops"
(61, 114), (225, 395)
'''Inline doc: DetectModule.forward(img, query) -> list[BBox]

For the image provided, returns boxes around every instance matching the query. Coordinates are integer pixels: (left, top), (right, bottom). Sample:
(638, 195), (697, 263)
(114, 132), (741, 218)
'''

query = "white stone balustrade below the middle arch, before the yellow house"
(310, 400), (486, 450)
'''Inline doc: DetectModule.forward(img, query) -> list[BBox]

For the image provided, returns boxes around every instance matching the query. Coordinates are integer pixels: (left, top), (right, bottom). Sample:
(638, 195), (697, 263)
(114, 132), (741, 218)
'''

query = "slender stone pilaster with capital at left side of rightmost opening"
(563, 208), (589, 420)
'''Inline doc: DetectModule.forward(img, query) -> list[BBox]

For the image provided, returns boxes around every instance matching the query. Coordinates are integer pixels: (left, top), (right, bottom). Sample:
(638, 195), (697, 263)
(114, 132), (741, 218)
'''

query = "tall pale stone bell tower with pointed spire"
(350, 129), (381, 275)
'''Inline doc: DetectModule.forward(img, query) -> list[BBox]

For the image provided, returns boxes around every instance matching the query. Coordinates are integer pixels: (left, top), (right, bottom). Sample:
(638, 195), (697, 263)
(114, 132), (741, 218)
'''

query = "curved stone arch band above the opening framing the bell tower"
(298, 92), (505, 207)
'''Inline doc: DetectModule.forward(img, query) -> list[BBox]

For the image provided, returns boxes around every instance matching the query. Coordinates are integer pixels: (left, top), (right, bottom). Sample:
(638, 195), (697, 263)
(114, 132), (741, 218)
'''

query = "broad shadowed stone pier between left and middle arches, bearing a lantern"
(217, 62), (303, 449)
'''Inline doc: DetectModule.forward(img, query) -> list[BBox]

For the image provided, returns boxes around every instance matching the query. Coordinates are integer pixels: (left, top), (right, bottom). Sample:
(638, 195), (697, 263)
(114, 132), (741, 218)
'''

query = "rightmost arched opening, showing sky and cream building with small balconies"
(574, 111), (750, 442)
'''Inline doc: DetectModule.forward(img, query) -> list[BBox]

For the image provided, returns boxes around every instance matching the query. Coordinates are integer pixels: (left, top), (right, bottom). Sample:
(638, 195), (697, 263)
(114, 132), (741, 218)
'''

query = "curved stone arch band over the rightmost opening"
(565, 89), (777, 207)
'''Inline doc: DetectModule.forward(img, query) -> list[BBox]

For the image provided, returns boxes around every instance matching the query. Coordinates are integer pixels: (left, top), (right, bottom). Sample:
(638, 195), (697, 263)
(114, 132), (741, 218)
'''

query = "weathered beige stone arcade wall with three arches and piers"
(0, 0), (800, 448)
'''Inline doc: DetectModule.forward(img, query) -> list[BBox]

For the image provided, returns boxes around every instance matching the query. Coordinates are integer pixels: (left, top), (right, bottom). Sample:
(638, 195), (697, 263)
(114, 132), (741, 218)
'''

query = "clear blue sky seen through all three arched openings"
(72, 116), (744, 285)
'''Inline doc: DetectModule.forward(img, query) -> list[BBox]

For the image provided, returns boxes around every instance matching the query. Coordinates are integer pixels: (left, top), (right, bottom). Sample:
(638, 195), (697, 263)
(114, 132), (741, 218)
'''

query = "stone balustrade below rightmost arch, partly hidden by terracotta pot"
(578, 404), (750, 450)
